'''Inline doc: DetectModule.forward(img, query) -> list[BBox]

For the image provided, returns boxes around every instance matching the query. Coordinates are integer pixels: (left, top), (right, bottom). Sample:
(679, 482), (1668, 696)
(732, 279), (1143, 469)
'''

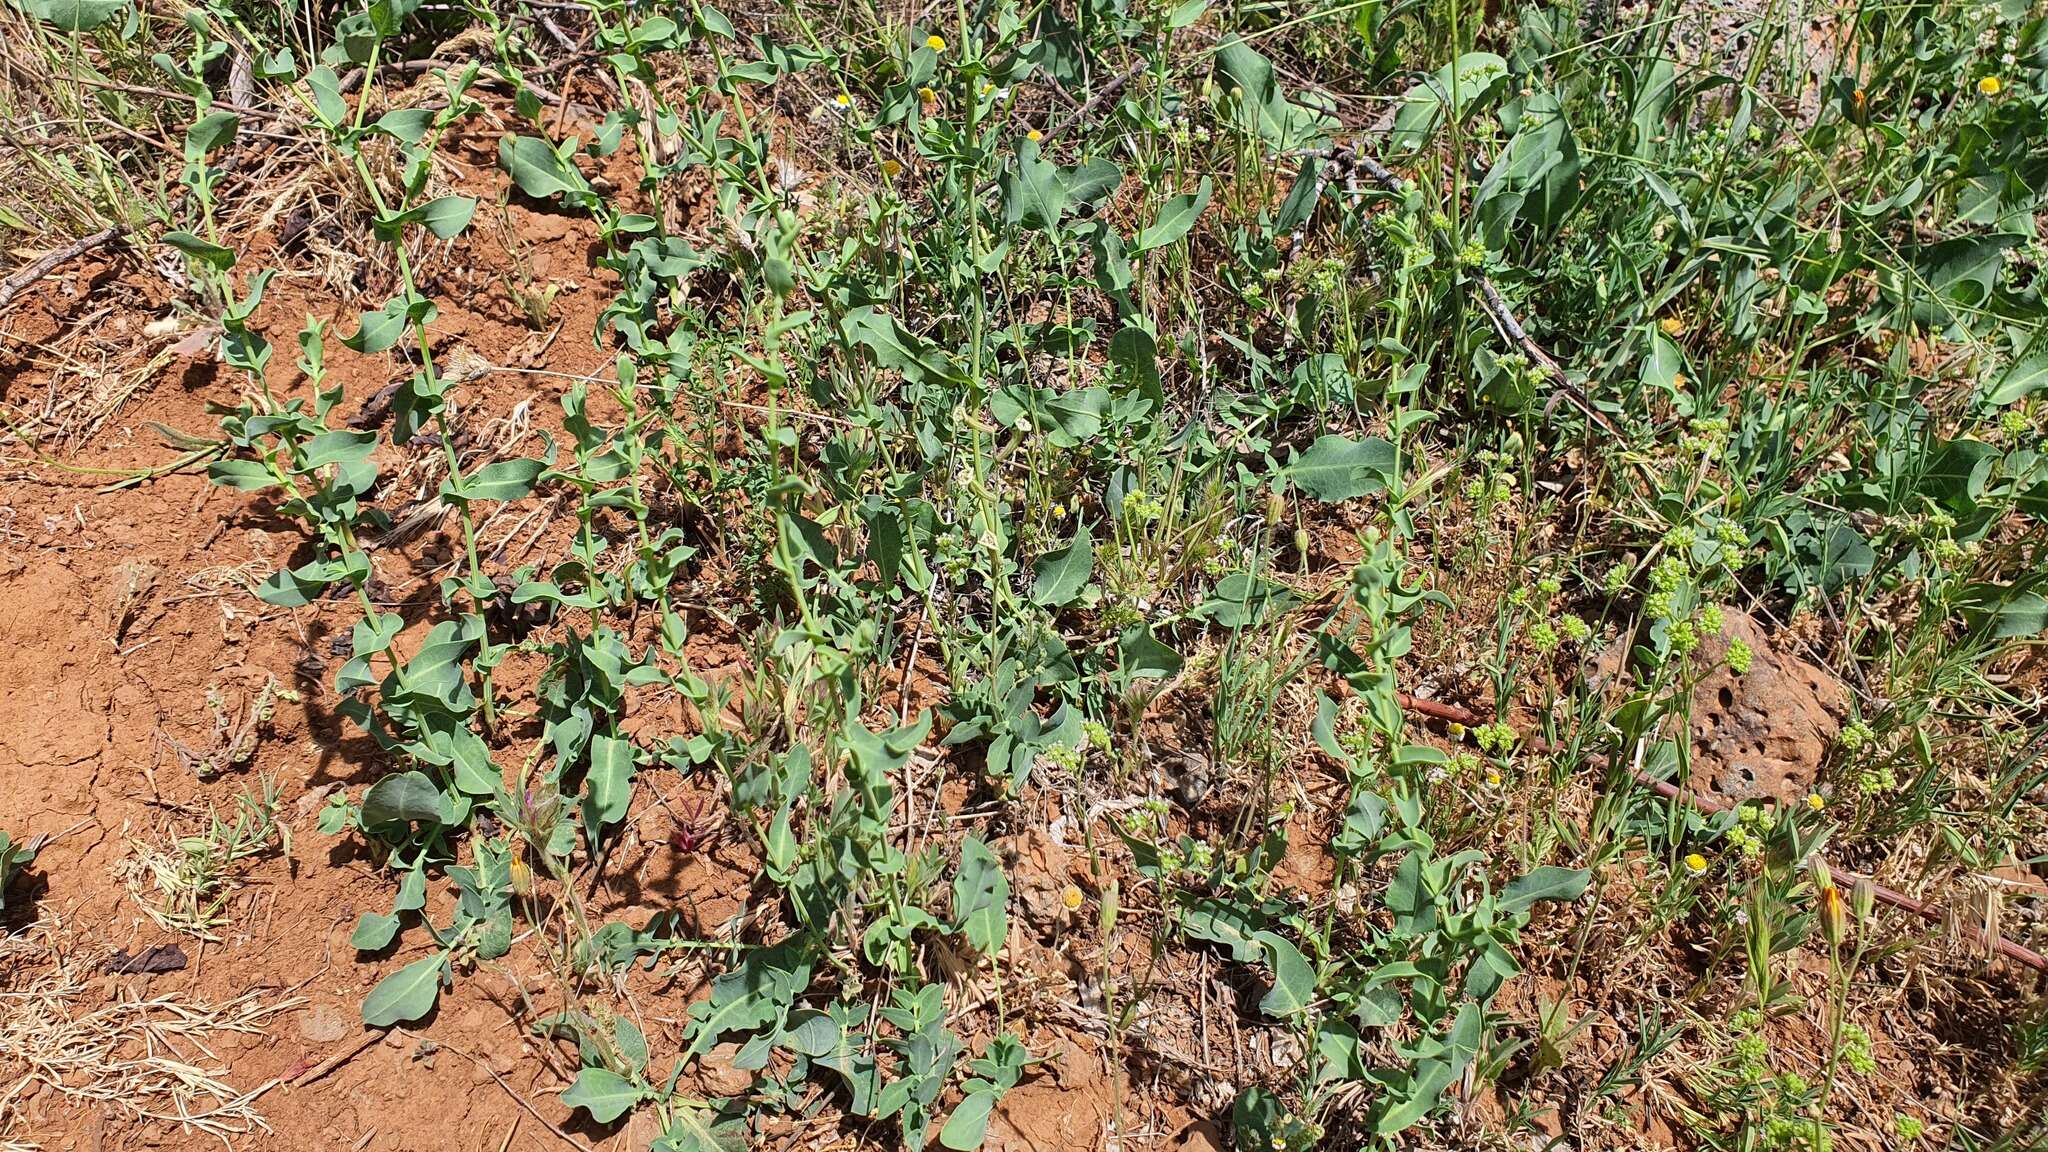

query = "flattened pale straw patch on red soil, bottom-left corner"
(0, 918), (303, 1150)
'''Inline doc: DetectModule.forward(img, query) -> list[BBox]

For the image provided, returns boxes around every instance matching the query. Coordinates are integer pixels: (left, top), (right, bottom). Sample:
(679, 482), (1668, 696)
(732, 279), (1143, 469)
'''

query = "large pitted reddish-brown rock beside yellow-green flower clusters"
(1692, 609), (1849, 804)
